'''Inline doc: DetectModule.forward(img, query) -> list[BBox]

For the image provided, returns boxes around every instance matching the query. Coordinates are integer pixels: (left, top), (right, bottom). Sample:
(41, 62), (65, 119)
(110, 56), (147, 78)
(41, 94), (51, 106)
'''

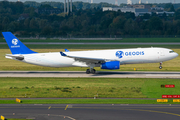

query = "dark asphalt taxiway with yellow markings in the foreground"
(0, 104), (180, 120)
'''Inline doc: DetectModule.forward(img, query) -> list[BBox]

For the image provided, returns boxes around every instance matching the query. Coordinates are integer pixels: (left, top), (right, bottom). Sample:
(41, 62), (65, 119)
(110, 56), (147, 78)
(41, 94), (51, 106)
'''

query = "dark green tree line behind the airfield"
(0, 1), (180, 36)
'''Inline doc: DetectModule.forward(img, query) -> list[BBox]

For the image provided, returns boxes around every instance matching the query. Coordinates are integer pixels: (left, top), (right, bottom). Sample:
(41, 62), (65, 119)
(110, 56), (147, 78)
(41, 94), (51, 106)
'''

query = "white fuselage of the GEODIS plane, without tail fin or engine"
(6, 48), (178, 67)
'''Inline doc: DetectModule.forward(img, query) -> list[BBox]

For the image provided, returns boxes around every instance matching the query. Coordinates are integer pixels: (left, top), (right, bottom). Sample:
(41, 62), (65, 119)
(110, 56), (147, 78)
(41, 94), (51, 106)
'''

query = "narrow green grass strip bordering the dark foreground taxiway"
(0, 99), (180, 104)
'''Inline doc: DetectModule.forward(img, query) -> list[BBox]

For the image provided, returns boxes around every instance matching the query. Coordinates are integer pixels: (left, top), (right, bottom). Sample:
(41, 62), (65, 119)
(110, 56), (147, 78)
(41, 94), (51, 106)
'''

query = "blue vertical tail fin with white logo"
(2, 32), (36, 54)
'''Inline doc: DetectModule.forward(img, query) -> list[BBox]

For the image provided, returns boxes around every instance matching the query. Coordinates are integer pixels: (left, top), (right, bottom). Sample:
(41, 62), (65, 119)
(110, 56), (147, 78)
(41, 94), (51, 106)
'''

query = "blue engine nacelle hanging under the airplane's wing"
(101, 61), (120, 70)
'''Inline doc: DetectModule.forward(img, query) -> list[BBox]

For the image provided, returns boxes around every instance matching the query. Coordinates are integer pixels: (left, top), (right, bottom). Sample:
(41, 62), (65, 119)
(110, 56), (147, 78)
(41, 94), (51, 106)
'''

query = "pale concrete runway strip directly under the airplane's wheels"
(0, 71), (180, 78)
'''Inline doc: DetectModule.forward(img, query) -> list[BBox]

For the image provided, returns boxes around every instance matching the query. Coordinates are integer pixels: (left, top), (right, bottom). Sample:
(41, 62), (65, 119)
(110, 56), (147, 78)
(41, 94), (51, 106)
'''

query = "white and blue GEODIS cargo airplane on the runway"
(2, 32), (178, 74)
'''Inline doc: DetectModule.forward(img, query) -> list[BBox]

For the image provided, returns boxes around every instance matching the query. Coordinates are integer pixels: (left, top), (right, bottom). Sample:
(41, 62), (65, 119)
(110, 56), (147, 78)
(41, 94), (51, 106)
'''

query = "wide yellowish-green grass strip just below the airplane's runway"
(0, 78), (180, 98)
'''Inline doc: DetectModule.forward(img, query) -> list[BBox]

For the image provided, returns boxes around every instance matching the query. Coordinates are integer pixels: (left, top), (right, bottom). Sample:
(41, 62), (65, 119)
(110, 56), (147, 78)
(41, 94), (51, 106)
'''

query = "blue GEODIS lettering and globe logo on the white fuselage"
(116, 51), (144, 58)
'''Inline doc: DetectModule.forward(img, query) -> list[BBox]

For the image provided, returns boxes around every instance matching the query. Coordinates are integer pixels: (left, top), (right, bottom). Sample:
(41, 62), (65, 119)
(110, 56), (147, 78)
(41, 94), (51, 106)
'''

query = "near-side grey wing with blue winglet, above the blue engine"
(60, 52), (107, 64)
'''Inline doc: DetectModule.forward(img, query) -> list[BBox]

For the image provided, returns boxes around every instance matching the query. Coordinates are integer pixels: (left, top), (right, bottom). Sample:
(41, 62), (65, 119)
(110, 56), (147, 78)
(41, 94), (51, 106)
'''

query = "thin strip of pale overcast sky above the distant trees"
(7, 0), (180, 4)
